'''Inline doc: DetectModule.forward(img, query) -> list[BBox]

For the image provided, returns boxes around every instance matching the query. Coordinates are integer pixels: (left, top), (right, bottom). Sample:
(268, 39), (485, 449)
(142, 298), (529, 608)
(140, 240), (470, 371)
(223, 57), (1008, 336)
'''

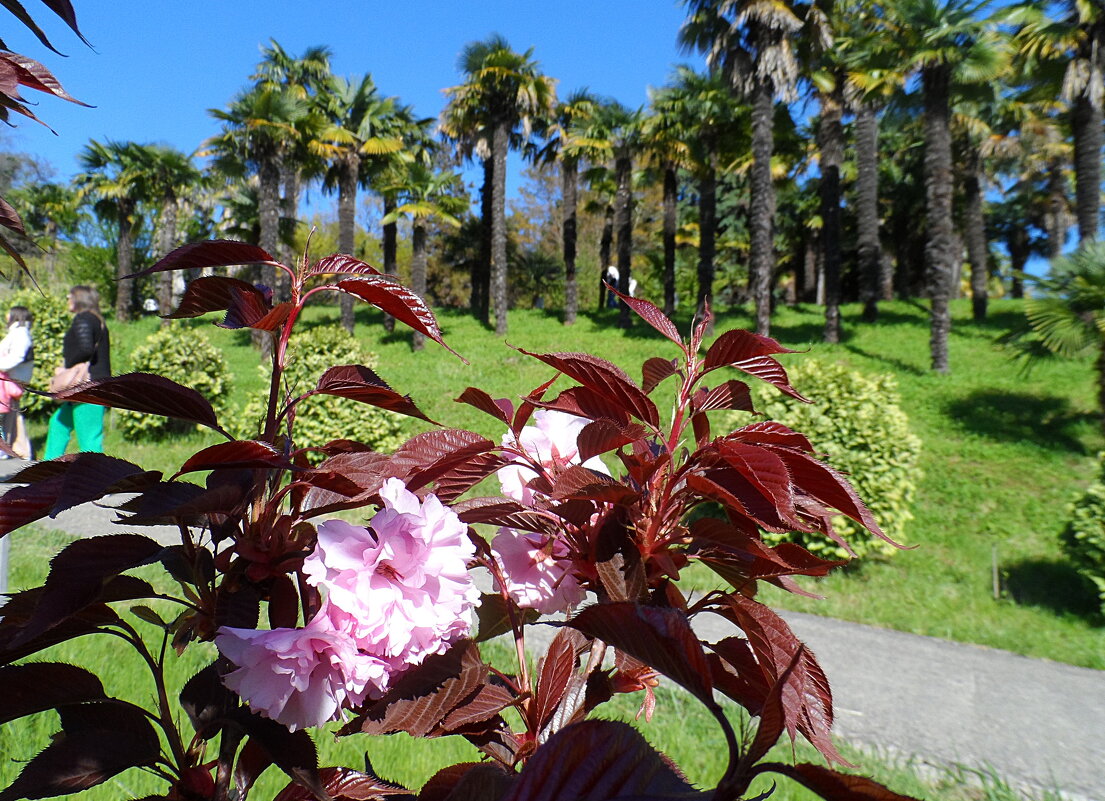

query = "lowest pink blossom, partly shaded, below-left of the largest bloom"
(214, 603), (390, 731)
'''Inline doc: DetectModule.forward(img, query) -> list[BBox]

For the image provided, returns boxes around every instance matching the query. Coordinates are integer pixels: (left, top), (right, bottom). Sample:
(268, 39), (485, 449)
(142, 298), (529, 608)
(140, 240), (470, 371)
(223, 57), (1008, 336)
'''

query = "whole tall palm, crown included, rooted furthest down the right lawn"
(887, 0), (1006, 372)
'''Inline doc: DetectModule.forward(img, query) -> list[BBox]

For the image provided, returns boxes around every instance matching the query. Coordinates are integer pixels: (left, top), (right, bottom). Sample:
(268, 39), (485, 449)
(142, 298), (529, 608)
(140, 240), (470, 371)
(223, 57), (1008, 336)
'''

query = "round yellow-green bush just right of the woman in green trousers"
(115, 324), (230, 441)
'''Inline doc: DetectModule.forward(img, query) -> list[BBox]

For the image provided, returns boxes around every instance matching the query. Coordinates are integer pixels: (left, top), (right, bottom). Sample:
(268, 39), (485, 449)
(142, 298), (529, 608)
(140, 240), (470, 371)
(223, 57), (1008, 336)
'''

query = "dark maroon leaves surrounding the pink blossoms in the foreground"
(0, 241), (919, 801)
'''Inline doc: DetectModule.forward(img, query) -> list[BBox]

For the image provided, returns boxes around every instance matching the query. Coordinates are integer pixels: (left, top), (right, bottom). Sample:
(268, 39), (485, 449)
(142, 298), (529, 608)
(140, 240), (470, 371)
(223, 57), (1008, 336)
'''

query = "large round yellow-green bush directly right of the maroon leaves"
(727, 360), (920, 559)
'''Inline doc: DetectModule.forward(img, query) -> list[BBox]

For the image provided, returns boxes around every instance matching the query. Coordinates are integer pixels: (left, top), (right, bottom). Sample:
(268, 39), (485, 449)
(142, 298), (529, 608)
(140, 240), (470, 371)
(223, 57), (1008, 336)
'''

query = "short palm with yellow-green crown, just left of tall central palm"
(383, 159), (469, 350)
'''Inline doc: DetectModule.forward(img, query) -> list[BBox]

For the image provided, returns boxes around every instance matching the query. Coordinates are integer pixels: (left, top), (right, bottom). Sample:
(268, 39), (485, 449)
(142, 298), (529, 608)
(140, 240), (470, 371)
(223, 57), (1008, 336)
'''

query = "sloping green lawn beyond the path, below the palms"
(10, 293), (1105, 668)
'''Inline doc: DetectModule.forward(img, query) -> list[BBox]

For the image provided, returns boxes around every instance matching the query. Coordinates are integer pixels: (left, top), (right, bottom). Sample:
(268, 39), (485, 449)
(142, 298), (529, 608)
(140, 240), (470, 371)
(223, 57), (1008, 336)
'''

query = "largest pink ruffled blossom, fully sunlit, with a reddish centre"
(303, 478), (480, 671)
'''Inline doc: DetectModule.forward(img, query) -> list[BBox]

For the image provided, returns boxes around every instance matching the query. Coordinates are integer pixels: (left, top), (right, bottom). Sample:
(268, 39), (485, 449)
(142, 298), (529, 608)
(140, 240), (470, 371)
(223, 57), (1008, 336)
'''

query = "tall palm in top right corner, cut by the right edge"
(1006, 0), (1105, 242)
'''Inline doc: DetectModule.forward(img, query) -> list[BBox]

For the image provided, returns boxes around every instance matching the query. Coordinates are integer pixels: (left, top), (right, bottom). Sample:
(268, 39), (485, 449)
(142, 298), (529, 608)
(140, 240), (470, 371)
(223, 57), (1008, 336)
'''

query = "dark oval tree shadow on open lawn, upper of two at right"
(945, 390), (1097, 454)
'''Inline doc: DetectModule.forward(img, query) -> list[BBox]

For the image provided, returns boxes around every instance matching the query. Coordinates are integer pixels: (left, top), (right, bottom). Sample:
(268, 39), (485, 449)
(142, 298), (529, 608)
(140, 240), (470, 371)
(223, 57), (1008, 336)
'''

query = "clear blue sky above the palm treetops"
(0, 0), (702, 194)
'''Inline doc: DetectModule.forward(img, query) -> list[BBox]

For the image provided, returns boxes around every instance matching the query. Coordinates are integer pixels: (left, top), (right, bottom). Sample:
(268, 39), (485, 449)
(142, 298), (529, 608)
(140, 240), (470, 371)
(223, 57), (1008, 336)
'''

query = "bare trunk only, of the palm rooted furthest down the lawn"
(922, 66), (956, 372)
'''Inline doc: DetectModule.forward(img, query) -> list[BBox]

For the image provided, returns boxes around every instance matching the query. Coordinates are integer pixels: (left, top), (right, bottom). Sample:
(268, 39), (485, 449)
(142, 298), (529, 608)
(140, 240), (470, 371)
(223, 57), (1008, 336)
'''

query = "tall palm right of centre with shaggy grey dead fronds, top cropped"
(680, 0), (802, 335)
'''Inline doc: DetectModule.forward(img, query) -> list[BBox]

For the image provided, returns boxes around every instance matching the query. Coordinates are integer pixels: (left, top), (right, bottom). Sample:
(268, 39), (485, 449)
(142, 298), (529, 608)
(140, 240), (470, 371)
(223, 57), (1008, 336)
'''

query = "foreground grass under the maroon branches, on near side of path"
(0, 525), (1056, 801)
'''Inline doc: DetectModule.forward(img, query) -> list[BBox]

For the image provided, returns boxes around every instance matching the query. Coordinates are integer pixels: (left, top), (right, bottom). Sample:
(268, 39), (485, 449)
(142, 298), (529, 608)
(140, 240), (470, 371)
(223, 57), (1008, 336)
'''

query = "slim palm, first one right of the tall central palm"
(539, 89), (611, 325)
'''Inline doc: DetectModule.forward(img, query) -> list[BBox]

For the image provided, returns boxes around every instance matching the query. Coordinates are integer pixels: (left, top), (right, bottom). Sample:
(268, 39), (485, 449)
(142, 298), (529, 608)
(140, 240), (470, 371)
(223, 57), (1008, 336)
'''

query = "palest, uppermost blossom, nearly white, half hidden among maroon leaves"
(497, 409), (610, 504)
